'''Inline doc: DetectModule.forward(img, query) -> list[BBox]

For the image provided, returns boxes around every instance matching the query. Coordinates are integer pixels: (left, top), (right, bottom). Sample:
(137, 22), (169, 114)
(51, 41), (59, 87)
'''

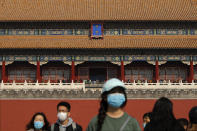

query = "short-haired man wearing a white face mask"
(51, 102), (82, 131)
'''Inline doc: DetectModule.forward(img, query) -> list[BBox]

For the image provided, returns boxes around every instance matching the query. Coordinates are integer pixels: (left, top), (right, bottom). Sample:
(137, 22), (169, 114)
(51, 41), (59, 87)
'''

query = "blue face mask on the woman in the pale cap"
(107, 93), (125, 108)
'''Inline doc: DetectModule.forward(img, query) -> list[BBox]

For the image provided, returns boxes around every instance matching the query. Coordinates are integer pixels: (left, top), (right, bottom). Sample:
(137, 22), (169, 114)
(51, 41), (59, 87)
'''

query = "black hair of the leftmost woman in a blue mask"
(26, 112), (49, 130)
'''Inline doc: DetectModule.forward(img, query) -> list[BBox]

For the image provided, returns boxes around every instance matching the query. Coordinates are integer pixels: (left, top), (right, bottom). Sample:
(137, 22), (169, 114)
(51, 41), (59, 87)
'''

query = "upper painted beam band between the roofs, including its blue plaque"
(0, 28), (197, 37)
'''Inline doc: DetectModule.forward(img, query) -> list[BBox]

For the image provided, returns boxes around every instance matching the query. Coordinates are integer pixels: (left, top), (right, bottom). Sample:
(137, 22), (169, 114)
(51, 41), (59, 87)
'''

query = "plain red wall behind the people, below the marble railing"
(0, 99), (197, 131)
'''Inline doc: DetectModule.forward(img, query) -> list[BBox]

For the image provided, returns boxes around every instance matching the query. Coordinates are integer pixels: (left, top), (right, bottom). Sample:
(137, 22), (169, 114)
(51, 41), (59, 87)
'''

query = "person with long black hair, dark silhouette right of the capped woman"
(144, 97), (184, 131)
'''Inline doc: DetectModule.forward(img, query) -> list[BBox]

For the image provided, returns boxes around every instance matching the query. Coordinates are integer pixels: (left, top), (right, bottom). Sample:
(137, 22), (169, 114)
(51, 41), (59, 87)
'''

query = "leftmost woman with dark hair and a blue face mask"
(26, 112), (50, 131)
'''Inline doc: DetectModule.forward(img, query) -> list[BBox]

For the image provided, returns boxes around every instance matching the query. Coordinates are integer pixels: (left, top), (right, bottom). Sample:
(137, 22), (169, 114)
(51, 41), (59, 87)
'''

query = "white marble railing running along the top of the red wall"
(0, 81), (197, 91)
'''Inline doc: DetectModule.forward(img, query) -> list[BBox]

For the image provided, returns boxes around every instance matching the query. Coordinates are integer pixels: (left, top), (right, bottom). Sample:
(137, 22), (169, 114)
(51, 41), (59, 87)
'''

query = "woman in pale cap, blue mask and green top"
(86, 78), (141, 131)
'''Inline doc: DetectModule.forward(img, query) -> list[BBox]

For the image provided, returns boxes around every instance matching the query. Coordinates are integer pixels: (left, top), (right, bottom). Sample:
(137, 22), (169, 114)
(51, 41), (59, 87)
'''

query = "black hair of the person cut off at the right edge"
(189, 106), (197, 126)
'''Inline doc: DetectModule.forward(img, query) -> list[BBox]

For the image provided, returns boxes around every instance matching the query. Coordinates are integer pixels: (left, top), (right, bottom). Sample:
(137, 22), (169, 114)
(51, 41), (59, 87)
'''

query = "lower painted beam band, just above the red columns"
(0, 55), (197, 62)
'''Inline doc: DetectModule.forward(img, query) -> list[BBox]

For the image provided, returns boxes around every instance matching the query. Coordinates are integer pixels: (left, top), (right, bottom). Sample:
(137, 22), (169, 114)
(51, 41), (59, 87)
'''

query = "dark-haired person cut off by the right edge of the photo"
(187, 106), (197, 131)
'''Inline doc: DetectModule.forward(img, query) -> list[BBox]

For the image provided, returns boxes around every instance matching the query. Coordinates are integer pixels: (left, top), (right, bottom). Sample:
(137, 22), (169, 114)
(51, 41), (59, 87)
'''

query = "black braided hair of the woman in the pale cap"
(97, 86), (127, 131)
